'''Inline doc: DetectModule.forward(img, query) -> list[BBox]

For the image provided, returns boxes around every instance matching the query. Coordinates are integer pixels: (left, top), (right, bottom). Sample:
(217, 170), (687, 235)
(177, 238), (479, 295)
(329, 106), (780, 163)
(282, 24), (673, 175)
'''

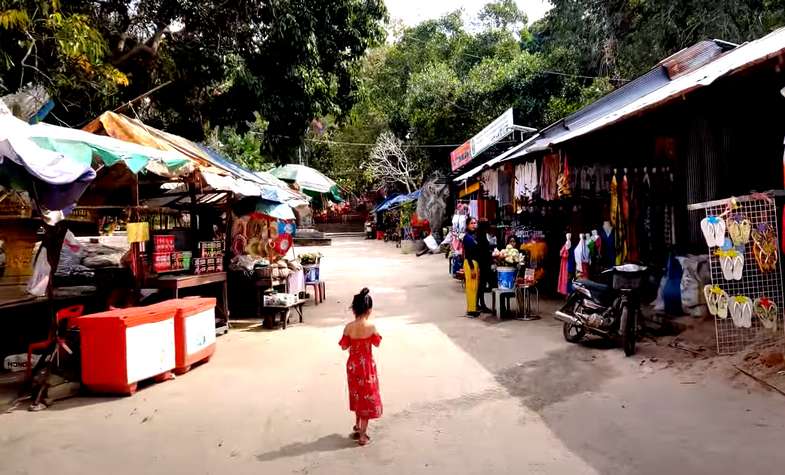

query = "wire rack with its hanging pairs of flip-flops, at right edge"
(689, 192), (785, 354)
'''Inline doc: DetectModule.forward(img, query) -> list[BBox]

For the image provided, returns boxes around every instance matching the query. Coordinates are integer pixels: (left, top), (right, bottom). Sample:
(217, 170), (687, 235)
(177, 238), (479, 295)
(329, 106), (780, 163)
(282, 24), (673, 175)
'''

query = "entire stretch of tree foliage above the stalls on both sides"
(0, 0), (785, 192)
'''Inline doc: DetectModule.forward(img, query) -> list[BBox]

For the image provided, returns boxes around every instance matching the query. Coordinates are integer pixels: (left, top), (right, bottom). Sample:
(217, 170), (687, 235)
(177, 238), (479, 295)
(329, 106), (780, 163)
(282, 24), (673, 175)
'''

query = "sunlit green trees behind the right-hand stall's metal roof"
(312, 0), (785, 193)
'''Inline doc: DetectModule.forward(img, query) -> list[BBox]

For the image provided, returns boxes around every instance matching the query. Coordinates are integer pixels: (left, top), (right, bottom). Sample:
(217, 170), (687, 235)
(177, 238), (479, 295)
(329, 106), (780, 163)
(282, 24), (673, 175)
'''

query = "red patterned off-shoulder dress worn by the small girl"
(340, 334), (382, 419)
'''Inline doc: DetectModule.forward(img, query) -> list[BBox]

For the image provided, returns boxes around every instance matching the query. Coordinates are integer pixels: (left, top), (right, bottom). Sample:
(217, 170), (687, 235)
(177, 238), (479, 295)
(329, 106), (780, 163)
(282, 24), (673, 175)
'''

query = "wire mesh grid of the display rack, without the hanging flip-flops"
(689, 193), (785, 354)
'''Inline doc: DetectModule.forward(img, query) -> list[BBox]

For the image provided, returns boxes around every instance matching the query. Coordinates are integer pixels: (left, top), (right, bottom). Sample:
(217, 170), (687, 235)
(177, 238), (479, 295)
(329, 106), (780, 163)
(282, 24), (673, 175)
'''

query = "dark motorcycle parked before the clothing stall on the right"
(556, 264), (646, 356)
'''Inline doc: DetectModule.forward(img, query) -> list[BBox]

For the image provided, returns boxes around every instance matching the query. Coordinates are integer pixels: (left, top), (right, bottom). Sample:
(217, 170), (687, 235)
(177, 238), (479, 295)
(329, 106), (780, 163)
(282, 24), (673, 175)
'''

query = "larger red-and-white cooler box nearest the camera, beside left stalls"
(77, 307), (175, 395)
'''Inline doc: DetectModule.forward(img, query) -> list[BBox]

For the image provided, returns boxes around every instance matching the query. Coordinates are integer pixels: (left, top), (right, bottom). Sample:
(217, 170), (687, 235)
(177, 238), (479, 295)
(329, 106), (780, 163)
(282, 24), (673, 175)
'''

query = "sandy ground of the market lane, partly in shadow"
(0, 239), (785, 475)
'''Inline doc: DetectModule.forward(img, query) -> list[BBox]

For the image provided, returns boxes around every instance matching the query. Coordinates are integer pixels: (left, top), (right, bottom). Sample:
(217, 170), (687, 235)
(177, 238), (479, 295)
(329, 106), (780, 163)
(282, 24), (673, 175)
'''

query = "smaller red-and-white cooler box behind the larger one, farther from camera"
(153, 297), (215, 374)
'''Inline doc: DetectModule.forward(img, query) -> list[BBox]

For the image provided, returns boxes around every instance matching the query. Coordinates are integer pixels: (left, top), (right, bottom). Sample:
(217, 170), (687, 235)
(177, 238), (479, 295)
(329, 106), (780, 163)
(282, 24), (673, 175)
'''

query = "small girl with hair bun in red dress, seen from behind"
(340, 289), (382, 445)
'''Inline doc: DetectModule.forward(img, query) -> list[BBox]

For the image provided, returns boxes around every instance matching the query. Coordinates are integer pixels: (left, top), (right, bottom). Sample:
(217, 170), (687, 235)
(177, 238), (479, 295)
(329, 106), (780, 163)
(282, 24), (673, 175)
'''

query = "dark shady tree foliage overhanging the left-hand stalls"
(0, 0), (386, 160)
